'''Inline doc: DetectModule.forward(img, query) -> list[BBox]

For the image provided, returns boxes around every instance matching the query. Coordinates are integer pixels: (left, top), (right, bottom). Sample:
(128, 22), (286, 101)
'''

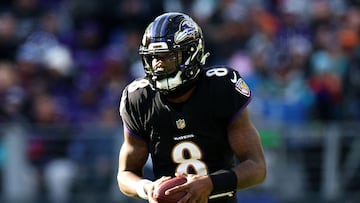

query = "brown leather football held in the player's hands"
(153, 177), (187, 203)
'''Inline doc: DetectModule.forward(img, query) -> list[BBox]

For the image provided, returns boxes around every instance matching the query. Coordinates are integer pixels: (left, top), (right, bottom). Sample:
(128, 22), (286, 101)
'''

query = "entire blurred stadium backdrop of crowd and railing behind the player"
(0, 0), (360, 203)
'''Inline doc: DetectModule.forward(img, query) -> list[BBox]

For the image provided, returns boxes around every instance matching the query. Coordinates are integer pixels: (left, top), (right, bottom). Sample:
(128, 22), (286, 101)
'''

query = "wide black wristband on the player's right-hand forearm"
(209, 170), (237, 194)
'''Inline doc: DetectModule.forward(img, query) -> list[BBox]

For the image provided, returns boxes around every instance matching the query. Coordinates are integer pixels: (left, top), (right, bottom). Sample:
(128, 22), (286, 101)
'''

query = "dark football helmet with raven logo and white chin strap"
(139, 12), (209, 96)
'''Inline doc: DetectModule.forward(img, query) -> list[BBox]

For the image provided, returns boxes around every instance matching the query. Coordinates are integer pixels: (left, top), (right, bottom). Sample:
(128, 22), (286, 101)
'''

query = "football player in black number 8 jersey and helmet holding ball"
(117, 12), (266, 203)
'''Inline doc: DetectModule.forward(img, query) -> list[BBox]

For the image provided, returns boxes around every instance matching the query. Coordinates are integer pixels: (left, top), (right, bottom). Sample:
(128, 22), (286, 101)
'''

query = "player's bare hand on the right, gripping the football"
(165, 174), (212, 203)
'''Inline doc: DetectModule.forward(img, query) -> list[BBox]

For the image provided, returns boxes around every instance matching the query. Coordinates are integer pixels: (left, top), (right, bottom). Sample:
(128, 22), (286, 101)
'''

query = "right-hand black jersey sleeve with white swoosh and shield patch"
(207, 67), (251, 124)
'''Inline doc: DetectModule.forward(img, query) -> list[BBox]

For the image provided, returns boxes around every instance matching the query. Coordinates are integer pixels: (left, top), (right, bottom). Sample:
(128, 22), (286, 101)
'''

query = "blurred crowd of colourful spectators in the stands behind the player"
(0, 0), (360, 202)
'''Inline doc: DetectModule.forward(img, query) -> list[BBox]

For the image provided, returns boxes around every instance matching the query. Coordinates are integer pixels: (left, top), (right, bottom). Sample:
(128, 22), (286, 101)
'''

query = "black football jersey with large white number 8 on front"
(120, 66), (251, 201)
